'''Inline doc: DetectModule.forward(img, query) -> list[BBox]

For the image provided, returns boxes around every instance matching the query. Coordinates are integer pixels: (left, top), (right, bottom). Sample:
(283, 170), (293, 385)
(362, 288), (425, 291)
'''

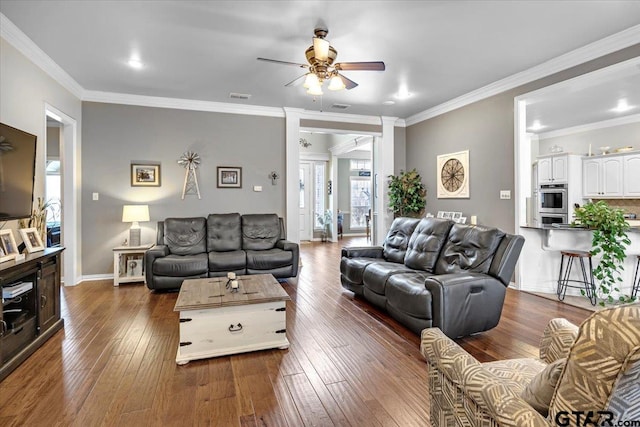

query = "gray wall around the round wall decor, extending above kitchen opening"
(406, 44), (640, 232)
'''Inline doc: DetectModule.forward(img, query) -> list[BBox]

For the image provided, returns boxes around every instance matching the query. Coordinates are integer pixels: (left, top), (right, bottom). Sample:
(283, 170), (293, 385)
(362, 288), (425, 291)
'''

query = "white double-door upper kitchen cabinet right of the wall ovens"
(582, 157), (624, 198)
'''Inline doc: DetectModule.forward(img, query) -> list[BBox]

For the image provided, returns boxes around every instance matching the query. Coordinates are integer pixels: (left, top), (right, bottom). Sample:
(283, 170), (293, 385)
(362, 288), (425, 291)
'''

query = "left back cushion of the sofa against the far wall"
(164, 217), (207, 258)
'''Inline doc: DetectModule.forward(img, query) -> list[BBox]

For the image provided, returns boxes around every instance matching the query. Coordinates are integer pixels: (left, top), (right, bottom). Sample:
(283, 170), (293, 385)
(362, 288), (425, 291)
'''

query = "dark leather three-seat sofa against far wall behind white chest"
(144, 213), (299, 290)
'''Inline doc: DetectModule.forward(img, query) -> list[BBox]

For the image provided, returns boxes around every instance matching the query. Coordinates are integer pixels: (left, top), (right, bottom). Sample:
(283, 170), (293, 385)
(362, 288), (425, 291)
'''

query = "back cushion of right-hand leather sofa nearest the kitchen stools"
(435, 224), (505, 274)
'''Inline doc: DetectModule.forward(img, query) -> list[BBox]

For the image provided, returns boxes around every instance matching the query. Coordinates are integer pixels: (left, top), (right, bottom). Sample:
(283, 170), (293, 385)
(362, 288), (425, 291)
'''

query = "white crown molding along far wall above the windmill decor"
(82, 90), (284, 117)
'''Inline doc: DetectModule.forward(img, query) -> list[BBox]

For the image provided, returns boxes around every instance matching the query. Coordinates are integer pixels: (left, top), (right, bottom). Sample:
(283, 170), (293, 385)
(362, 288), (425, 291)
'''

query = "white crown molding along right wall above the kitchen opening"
(405, 25), (640, 126)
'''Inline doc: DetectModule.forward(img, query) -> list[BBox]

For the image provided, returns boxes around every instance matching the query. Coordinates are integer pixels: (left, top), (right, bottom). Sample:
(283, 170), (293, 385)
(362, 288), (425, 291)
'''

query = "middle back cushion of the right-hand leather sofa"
(404, 218), (453, 273)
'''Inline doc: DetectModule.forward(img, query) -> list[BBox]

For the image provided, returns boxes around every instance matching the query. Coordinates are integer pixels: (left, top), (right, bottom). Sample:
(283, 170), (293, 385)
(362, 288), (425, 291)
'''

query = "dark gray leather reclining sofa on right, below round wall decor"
(340, 218), (524, 338)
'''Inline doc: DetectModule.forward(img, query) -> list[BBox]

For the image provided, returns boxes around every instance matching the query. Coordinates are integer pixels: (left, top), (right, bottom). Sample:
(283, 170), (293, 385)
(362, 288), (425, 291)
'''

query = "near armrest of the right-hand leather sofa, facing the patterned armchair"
(425, 273), (506, 338)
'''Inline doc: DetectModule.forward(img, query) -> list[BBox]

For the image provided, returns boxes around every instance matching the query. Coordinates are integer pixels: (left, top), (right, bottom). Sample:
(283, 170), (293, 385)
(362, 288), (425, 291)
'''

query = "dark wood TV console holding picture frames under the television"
(0, 248), (64, 381)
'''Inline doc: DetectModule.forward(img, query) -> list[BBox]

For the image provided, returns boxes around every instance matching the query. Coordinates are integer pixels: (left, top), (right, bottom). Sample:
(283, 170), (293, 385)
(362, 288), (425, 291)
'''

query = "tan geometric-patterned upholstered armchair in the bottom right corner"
(421, 303), (640, 427)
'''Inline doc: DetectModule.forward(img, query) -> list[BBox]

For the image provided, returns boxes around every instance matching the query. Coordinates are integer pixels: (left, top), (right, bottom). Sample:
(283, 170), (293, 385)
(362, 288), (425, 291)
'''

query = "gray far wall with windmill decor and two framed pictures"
(82, 102), (285, 275)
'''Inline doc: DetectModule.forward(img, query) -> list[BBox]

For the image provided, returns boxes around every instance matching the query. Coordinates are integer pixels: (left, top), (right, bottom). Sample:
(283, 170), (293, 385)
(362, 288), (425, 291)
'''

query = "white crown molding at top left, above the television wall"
(0, 13), (84, 99)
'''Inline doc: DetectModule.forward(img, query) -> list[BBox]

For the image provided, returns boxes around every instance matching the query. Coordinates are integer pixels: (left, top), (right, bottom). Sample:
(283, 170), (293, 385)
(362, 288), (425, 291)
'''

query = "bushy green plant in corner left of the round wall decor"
(388, 168), (427, 217)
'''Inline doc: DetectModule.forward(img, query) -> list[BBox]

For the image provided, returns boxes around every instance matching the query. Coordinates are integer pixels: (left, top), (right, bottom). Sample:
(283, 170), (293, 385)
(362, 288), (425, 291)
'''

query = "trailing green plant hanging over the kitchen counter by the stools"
(572, 200), (635, 306)
